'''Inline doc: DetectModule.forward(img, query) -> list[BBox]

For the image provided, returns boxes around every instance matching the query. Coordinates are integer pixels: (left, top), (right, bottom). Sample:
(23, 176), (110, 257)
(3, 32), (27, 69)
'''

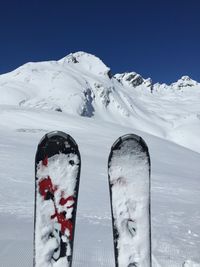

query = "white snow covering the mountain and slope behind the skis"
(0, 52), (200, 267)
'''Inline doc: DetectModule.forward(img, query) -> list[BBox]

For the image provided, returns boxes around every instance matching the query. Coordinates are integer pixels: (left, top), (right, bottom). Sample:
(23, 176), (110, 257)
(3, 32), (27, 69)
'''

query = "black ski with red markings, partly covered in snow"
(33, 131), (81, 267)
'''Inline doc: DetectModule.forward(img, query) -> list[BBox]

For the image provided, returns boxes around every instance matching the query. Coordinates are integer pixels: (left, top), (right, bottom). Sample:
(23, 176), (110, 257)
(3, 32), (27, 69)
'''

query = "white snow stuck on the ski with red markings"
(35, 153), (79, 267)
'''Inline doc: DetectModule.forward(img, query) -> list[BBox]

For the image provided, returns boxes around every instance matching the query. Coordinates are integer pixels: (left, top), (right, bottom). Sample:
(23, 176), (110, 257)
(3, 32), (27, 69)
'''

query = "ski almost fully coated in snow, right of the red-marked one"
(108, 134), (151, 267)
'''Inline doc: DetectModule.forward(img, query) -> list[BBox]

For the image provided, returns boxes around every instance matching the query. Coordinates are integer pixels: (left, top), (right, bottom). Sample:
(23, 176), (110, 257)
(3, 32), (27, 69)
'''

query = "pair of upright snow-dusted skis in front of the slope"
(34, 131), (151, 267)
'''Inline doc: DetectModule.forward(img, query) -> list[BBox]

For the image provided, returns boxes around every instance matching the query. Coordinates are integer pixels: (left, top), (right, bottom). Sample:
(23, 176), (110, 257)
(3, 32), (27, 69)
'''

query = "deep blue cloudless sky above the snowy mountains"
(0, 0), (200, 83)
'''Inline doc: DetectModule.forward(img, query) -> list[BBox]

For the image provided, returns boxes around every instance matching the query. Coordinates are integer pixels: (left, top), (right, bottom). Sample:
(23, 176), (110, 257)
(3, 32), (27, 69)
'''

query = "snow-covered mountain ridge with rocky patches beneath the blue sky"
(0, 52), (200, 151)
